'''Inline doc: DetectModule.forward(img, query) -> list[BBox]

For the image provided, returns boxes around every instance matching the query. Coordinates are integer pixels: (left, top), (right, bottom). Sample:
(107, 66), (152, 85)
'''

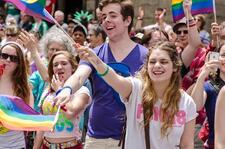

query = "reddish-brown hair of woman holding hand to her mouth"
(48, 51), (78, 92)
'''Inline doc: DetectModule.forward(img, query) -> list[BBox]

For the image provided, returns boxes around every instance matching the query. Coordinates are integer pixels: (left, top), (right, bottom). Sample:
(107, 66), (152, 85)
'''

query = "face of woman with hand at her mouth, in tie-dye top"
(53, 54), (73, 82)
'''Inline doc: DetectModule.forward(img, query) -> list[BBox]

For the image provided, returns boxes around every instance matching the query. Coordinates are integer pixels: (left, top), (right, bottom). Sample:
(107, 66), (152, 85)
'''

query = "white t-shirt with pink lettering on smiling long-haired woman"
(122, 78), (197, 149)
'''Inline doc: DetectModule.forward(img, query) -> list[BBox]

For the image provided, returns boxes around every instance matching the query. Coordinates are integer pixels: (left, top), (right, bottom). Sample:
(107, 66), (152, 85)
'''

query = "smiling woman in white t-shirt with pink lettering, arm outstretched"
(77, 42), (197, 149)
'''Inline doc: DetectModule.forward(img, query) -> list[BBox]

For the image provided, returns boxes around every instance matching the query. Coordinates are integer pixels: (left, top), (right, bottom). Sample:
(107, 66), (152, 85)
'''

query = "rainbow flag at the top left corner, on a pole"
(4, 0), (54, 23)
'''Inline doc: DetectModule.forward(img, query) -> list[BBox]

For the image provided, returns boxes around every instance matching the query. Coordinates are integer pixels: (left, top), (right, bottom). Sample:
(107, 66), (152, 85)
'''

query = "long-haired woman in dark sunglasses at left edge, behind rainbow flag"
(0, 42), (33, 148)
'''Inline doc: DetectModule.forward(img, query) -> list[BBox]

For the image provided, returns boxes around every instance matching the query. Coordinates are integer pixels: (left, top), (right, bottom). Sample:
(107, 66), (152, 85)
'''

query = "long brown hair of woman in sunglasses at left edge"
(0, 42), (30, 104)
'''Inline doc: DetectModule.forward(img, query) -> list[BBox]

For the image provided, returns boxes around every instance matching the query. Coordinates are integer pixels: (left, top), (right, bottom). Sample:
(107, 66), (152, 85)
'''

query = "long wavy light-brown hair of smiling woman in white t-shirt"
(137, 42), (181, 137)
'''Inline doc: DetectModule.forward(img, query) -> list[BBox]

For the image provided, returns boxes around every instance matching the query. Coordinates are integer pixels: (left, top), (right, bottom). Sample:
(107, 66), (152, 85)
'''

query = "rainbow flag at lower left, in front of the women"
(0, 95), (60, 131)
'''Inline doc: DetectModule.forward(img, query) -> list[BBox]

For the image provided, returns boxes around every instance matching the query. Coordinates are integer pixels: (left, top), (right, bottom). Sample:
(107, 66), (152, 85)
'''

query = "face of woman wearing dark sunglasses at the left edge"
(0, 45), (19, 74)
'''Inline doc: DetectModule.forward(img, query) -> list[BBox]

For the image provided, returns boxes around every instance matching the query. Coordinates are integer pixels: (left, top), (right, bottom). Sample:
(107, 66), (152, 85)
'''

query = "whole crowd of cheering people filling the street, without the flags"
(0, 0), (225, 149)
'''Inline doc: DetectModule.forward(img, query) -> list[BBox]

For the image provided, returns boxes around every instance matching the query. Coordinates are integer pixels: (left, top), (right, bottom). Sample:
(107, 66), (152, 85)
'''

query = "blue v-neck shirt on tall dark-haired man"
(80, 43), (148, 139)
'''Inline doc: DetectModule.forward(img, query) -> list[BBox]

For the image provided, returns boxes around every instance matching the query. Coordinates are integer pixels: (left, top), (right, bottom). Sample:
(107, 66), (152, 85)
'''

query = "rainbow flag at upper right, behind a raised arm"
(172, 0), (213, 22)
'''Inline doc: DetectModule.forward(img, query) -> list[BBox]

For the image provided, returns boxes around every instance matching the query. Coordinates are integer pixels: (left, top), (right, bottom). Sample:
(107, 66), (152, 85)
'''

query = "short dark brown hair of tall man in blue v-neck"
(98, 0), (134, 32)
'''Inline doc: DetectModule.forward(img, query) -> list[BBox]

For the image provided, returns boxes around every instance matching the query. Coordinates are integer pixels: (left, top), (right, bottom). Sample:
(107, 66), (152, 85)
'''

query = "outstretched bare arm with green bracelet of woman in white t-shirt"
(77, 47), (132, 99)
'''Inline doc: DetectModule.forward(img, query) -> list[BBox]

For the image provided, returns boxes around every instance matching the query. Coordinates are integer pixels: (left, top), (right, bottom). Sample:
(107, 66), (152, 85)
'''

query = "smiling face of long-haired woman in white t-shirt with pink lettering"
(148, 49), (174, 83)
